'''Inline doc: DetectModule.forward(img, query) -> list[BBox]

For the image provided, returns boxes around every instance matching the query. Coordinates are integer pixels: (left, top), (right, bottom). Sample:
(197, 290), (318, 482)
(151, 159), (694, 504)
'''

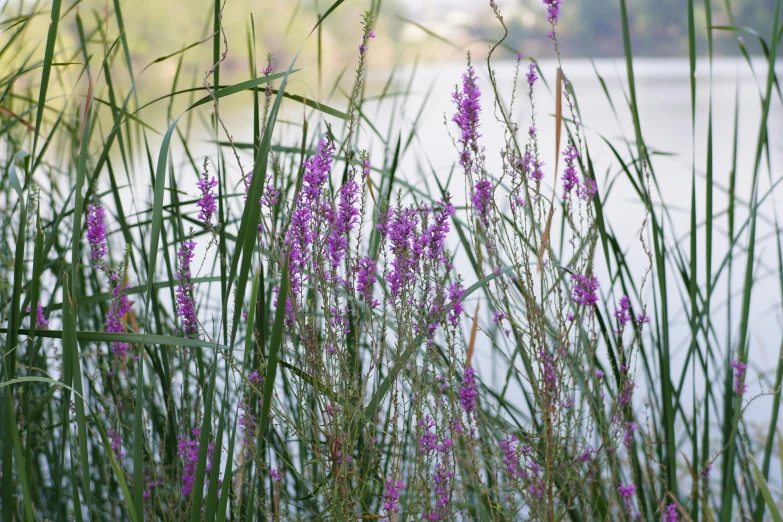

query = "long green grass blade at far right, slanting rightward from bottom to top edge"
(721, 0), (781, 522)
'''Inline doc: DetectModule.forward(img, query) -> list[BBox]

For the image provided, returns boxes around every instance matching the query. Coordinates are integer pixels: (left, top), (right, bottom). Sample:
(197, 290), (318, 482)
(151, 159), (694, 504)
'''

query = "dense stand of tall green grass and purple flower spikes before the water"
(0, 0), (783, 521)
